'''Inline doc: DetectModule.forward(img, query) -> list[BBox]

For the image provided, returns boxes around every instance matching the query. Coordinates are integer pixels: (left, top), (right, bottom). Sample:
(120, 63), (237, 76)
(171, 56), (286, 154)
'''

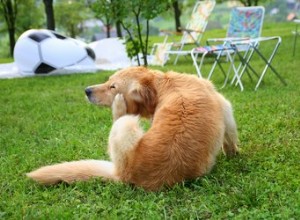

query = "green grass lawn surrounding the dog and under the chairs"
(0, 24), (300, 219)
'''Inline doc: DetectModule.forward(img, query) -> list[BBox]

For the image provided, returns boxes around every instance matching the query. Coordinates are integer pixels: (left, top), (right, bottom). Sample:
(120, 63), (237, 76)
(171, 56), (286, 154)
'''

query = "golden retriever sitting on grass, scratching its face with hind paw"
(27, 67), (238, 191)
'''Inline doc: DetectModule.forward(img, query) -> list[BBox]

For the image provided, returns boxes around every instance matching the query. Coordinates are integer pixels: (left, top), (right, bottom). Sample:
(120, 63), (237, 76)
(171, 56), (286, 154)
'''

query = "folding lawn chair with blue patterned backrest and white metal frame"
(191, 6), (265, 90)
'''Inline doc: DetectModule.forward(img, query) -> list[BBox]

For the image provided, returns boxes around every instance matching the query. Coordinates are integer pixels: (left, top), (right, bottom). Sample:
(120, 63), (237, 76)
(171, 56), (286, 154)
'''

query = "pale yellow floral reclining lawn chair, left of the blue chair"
(150, 0), (216, 65)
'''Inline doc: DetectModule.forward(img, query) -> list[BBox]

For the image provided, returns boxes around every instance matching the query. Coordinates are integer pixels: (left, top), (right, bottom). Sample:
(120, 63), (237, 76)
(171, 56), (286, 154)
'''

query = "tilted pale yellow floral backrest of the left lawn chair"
(181, 0), (216, 44)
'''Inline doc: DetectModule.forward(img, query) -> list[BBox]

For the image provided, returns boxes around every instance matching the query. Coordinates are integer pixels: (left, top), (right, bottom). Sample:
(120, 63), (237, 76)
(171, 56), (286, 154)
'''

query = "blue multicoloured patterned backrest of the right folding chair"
(227, 6), (265, 38)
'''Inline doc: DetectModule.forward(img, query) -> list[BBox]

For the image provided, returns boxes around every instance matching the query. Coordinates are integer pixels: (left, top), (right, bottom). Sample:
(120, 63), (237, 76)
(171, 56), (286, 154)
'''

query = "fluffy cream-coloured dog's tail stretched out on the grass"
(26, 160), (118, 185)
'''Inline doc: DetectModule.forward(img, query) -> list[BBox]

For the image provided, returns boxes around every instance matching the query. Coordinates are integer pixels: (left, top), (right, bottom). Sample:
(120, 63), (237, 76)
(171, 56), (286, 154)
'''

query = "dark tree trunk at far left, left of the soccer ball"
(0, 0), (18, 56)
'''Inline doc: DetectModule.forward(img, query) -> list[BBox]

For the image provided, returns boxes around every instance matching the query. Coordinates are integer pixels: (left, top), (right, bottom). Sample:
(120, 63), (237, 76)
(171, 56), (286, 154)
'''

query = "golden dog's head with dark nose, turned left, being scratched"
(85, 67), (157, 116)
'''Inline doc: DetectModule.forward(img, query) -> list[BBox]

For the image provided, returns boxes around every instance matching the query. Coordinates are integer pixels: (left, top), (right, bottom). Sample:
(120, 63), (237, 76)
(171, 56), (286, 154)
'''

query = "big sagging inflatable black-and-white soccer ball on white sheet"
(14, 29), (95, 75)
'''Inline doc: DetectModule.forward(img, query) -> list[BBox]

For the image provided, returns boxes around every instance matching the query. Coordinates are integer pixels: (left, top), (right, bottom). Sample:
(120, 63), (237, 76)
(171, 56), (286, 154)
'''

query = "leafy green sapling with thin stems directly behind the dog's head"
(92, 0), (172, 65)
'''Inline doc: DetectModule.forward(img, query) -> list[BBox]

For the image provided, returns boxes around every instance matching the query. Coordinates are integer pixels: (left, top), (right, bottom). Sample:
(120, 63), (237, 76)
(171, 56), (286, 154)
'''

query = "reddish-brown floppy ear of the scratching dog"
(129, 82), (156, 108)
